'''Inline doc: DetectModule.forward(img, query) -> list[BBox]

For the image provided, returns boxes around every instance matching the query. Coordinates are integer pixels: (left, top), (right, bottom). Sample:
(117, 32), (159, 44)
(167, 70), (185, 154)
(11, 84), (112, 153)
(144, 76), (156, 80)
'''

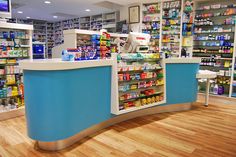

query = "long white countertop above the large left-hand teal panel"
(19, 58), (113, 70)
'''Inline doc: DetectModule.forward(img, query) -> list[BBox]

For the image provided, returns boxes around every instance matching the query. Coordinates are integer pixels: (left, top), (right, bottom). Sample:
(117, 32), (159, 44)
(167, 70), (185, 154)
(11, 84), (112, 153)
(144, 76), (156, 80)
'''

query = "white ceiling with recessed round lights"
(12, 0), (139, 21)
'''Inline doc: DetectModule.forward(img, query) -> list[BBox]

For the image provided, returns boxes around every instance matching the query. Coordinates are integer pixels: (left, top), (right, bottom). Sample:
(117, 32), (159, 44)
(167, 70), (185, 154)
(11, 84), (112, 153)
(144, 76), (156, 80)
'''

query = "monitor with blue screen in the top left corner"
(0, 0), (11, 19)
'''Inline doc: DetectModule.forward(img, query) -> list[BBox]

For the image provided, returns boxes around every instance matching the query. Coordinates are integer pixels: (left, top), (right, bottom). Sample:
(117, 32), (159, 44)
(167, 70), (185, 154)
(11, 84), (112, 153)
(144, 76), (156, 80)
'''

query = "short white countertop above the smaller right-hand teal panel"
(164, 58), (201, 64)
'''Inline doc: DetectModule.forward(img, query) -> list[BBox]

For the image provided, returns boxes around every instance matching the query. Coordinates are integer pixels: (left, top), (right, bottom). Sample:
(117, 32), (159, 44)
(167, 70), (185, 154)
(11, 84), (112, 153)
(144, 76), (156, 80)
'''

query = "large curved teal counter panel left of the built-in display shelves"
(24, 67), (111, 141)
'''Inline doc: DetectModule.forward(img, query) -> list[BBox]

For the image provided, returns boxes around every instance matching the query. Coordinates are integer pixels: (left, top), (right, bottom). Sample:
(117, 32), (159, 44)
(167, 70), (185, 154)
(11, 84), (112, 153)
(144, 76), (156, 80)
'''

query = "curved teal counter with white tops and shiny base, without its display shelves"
(20, 59), (200, 150)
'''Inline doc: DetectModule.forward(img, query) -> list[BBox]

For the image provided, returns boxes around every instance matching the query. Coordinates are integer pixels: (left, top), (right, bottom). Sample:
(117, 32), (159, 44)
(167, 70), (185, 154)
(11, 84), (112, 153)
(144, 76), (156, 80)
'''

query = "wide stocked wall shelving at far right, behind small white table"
(193, 0), (236, 97)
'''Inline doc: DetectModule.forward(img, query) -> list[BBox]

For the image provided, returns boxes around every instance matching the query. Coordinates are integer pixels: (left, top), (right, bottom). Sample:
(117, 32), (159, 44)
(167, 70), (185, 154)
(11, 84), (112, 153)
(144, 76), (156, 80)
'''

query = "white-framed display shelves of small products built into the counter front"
(111, 53), (166, 115)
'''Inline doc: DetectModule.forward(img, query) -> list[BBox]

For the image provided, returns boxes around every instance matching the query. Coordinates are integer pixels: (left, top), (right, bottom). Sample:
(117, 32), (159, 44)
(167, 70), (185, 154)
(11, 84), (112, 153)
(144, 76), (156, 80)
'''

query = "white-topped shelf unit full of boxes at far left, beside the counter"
(0, 23), (33, 119)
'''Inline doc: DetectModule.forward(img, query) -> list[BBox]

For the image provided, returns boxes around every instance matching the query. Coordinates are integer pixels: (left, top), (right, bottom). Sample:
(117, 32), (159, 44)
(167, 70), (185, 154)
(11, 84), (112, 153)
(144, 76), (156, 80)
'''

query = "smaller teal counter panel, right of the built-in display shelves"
(166, 64), (199, 104)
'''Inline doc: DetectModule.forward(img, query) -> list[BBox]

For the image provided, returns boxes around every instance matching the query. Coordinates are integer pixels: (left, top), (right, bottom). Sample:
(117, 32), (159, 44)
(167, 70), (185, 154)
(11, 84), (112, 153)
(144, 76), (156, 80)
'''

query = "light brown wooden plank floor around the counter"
(0, 97), (236, 157)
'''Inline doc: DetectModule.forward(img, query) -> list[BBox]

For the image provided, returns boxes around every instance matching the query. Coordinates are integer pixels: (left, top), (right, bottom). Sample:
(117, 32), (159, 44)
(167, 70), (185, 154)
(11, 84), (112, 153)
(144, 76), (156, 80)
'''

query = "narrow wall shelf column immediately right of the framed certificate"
(142, 3), (161, 53)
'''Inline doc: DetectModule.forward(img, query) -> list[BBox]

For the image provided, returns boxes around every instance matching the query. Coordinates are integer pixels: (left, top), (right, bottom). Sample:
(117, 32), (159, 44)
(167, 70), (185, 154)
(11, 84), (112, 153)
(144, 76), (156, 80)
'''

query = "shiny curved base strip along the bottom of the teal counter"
(36, 103), (192, 151)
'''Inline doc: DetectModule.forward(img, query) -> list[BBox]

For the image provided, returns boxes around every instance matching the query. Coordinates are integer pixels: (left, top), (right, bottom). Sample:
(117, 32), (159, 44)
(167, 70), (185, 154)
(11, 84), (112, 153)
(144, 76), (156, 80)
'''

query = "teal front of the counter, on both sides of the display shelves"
(21, 58), (199, 151)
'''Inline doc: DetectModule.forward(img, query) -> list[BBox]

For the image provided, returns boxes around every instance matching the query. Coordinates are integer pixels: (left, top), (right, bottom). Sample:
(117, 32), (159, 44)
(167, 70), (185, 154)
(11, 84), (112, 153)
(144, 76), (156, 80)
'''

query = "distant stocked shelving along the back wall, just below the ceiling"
(9, 12), (119, 58)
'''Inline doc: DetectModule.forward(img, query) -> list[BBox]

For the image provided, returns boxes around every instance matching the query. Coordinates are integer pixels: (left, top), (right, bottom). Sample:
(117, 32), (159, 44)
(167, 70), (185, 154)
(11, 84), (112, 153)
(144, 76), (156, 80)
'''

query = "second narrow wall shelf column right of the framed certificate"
(161, 0), (182, 57)
